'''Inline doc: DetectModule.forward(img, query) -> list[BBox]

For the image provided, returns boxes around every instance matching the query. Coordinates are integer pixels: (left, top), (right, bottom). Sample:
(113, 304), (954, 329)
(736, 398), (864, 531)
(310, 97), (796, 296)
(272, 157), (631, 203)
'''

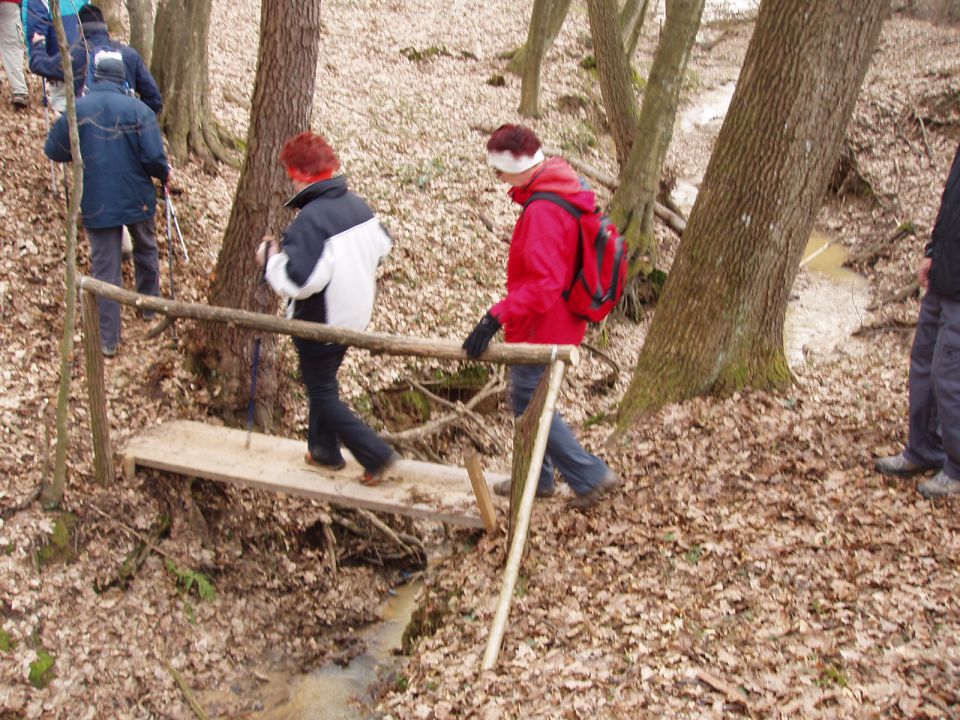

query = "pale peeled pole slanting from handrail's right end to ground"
(483, 360), (566, 670)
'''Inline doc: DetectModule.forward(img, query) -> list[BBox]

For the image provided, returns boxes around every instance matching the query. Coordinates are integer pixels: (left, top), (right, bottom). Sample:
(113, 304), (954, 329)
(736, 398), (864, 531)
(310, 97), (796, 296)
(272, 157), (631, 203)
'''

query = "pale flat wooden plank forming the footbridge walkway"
(123, 420), (507, 528)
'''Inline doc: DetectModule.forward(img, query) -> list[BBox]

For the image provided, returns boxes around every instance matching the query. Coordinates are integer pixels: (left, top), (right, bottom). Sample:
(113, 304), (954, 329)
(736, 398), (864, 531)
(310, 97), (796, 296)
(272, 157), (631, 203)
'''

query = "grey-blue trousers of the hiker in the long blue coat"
(87, 217), (160, 347)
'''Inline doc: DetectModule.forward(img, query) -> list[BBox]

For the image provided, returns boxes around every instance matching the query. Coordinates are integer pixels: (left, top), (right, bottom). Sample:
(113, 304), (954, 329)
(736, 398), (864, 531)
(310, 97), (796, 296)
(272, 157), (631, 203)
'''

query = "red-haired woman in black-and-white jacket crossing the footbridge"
(257, 132), (398, 485)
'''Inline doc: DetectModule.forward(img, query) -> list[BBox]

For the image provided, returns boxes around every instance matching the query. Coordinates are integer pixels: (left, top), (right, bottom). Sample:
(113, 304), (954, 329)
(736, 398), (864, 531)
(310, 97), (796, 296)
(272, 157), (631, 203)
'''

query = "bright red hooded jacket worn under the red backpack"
(490, 158), (596, 345)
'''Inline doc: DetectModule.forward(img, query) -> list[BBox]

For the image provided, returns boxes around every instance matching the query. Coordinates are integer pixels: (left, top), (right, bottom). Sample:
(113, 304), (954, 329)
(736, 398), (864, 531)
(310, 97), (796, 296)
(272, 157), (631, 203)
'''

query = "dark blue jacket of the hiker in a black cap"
(30, 21), (163, 115)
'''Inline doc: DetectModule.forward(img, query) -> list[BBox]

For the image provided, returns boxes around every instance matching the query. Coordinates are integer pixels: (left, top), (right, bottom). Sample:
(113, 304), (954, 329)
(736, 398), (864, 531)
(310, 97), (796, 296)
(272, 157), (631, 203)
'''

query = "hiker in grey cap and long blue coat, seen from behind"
(44, 50), (170, 357)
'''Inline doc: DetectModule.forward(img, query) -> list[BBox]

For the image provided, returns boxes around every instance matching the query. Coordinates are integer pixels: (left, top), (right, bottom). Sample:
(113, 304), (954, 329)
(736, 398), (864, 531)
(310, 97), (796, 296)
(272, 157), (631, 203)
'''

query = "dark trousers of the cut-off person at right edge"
(904, 291), (960, 480)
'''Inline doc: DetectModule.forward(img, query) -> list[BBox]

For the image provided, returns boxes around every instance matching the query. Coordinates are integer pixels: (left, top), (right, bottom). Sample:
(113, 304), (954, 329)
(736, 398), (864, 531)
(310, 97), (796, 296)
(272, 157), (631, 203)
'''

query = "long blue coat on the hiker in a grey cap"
(44, 80), (169, 228)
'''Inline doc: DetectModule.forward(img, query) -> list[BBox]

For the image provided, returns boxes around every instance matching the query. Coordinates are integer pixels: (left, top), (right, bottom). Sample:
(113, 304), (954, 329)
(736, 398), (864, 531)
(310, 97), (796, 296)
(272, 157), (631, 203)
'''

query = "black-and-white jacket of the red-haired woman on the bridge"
(266, 175), (392, 330)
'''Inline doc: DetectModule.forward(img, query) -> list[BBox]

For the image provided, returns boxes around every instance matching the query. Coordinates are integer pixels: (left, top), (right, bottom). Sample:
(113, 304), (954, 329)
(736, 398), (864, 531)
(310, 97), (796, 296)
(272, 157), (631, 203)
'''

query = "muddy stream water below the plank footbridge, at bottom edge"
(252, 581), (421, 720)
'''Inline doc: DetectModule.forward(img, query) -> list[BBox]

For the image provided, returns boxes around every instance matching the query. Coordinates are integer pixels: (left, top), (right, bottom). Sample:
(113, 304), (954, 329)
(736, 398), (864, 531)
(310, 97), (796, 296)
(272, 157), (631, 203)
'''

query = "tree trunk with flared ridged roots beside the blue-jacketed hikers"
(151, 0), (239, 165)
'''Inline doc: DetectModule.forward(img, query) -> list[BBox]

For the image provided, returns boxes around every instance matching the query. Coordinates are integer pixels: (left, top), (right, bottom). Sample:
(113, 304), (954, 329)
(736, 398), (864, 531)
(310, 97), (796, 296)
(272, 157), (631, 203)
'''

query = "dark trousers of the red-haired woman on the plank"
(294, 340), (393, 472)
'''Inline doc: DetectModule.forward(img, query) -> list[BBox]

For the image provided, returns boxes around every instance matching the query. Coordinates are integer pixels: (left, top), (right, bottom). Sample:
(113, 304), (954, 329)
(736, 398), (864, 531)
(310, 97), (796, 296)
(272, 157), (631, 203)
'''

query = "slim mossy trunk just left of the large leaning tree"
(611, 0), (704, 319)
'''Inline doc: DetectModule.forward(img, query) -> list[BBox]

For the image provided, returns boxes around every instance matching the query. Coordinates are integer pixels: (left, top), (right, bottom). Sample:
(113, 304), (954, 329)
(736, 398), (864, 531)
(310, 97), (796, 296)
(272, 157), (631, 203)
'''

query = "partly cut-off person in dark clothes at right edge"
(876, 146), (960, 498)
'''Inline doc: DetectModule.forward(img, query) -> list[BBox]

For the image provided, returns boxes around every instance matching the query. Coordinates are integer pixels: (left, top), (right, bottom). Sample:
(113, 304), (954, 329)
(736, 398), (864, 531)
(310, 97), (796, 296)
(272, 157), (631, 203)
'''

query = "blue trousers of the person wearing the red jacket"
(510, 365), (610, 495)
